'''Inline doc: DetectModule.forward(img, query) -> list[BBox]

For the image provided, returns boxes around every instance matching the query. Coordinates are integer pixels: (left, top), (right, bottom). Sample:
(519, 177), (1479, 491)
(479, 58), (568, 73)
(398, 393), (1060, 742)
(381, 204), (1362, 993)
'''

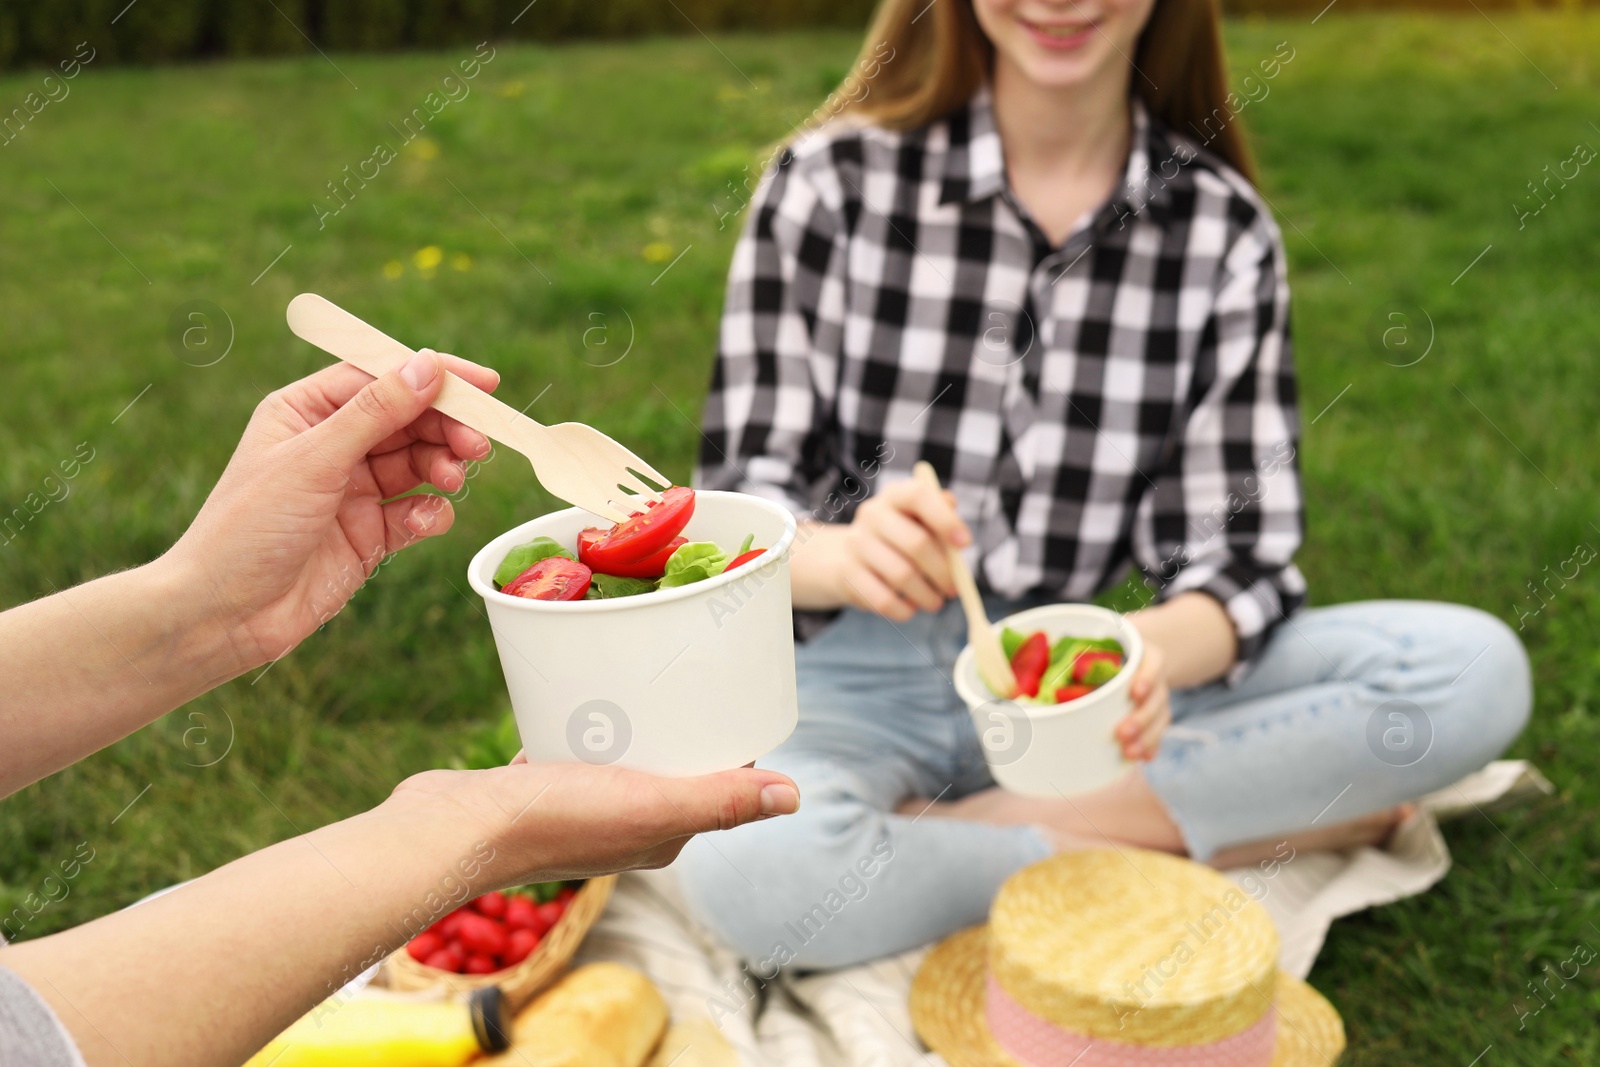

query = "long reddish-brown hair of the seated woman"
(830, 0), (1256, 182)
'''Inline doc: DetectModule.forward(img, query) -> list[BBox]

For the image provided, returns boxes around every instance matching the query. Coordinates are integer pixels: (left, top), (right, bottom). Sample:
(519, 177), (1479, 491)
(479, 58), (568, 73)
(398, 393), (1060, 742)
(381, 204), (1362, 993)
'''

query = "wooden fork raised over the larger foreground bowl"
(288, 293), (672, 523)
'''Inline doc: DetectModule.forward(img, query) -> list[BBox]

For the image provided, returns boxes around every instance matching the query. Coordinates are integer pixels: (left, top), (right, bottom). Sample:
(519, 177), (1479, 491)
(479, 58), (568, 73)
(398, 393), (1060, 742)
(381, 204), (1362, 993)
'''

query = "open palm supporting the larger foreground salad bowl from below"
(386, 757), (800, 893)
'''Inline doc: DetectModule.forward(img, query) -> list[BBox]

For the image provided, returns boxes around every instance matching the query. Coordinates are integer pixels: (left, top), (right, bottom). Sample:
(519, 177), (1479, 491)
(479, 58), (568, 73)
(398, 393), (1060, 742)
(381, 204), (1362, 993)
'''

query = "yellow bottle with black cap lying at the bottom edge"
(245, 987), (509, 1067)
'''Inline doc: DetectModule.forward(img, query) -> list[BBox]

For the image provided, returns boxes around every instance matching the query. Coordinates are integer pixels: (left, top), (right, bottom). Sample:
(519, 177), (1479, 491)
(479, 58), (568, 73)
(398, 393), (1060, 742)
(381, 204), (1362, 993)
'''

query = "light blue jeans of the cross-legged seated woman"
(677, 601), (1533, 977)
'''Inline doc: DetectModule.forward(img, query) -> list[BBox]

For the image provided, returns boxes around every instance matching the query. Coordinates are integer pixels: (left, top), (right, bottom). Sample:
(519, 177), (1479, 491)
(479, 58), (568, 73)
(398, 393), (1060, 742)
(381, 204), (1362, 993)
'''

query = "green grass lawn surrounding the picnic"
(0, 11), (1600, 1067)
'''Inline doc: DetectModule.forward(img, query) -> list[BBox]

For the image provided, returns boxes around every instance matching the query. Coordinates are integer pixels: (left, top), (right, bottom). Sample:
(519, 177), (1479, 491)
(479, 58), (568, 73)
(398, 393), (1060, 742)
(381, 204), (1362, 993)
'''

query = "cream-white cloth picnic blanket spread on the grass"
(578, 760), (1550, 1067)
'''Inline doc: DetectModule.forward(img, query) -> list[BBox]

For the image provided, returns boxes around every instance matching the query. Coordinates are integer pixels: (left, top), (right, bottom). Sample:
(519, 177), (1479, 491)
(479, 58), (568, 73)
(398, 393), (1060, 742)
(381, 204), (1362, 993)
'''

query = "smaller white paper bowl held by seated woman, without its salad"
(955, 605), (1144, 797)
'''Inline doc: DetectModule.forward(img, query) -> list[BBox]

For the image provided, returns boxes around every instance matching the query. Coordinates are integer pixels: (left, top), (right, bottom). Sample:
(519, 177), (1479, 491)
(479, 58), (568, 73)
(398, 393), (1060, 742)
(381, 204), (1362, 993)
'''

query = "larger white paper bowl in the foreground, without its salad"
(467, 491), (798, 776)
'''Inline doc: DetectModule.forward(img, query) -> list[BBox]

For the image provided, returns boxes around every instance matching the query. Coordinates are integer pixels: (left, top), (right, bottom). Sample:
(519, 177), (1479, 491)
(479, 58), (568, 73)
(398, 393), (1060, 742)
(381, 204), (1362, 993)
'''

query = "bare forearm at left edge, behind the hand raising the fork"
(0, 560), (250, 797)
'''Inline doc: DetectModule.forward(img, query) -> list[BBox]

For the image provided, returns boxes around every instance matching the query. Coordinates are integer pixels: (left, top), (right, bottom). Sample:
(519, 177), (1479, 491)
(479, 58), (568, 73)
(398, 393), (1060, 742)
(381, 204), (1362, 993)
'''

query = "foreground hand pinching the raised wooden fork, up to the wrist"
(163, 349), (499, 670)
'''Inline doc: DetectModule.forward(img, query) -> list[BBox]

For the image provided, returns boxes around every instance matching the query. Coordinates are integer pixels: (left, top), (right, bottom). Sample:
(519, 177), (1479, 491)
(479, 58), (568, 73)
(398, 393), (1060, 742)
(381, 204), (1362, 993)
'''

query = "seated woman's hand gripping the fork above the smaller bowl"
(792, 482), (973, 622)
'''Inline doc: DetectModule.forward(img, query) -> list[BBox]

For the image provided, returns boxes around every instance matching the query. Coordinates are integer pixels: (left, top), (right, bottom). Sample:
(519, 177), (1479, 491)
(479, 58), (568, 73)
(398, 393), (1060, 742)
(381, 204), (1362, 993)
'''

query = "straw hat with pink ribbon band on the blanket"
(910, 849), (1344, 1067)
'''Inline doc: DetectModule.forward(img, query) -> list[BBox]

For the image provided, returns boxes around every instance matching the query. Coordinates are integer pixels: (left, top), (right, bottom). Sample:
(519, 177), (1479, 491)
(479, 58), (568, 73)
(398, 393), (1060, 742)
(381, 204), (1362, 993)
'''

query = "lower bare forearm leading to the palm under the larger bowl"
(0, 801), (492, 1067)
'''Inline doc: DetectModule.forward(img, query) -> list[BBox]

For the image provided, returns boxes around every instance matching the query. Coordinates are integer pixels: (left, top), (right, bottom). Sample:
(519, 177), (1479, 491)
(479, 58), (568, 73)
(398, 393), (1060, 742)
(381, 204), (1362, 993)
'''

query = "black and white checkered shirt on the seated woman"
(698, 93), (1306, 657)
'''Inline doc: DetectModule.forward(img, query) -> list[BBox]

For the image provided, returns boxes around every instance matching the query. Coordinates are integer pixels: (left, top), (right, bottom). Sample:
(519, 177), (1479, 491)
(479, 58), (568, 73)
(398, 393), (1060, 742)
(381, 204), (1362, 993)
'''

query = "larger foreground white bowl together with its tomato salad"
(467, 488), (798, 776)
